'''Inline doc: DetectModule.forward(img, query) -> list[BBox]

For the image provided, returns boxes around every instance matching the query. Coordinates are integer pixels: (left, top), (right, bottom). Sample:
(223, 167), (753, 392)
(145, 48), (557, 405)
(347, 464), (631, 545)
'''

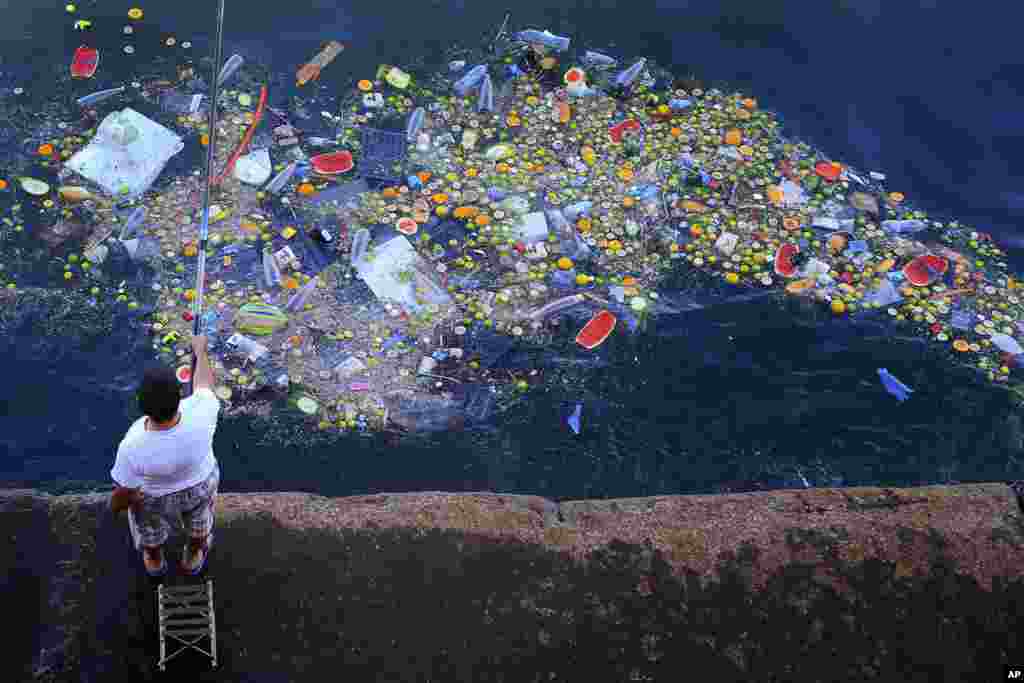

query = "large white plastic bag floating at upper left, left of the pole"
(67, 109), (184, 198)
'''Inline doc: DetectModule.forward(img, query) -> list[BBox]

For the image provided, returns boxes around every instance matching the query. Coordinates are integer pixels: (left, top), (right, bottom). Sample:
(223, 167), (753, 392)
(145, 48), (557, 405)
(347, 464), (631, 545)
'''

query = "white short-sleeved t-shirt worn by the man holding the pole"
(111, 387), (220, 497)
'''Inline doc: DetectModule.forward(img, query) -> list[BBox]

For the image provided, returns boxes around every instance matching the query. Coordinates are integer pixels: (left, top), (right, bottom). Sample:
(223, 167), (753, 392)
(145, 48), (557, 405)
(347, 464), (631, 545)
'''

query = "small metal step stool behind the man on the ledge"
(157, 579), (217, 671)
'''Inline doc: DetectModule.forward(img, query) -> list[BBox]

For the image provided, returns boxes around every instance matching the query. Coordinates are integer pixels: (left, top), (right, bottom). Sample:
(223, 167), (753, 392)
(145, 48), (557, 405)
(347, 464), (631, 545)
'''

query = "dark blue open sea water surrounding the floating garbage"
(0, 0), (1024, 499)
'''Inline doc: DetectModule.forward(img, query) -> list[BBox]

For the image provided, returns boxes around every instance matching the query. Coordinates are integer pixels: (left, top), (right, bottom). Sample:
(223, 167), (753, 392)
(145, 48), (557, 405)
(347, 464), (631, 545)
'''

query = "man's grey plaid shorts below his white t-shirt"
(128, 465), (220, 550)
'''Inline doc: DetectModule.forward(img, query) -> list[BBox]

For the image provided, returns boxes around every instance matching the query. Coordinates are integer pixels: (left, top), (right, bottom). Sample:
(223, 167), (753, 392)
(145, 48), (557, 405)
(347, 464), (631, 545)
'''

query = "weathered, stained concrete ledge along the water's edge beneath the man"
(0, 483), (1024, 683)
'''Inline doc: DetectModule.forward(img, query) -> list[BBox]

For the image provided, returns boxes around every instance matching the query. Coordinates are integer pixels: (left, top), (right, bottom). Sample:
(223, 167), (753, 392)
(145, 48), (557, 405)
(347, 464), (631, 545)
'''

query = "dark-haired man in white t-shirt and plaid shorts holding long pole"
(111, 335), (220, 578)
